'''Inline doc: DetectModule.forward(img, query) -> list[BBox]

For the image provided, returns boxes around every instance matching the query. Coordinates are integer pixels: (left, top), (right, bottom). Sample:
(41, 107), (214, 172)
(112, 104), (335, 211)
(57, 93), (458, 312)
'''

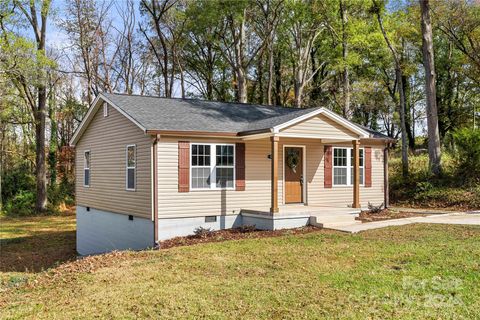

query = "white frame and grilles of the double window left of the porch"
(189, 142), (237, 191)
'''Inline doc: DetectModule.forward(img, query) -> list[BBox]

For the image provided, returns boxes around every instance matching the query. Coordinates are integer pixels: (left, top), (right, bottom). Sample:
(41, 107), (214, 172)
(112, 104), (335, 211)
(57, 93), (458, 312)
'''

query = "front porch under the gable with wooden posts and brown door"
(264, 135), (362, 216)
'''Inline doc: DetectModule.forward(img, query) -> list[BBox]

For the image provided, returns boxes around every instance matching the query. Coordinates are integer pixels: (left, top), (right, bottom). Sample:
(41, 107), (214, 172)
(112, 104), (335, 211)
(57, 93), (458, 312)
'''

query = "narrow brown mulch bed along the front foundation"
(160, 226), (321, 249)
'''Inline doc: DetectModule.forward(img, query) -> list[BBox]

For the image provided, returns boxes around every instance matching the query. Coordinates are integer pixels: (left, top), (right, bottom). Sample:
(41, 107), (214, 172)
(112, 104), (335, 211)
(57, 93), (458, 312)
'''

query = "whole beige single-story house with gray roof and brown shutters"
(71, 93), (390, 254)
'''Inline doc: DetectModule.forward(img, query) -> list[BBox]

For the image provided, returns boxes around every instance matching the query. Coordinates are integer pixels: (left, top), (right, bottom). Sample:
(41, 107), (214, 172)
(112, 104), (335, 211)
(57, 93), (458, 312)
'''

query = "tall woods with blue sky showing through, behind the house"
(0, 0), (480, 214)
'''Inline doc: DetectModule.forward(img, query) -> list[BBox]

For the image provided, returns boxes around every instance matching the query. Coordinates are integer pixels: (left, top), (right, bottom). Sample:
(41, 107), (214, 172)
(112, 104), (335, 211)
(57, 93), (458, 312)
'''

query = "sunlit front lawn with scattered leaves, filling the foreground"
(0, 221), (480, 319)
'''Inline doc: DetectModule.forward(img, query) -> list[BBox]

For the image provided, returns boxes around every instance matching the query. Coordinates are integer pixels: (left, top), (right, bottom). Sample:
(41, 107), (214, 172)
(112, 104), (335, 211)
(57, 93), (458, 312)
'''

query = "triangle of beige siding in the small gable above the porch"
(281, 114), (358, 139)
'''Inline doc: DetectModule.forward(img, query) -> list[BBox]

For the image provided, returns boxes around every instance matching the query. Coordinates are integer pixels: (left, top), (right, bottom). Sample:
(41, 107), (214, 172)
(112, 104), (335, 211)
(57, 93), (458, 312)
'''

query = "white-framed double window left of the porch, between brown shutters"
(190, 144), (235, 189)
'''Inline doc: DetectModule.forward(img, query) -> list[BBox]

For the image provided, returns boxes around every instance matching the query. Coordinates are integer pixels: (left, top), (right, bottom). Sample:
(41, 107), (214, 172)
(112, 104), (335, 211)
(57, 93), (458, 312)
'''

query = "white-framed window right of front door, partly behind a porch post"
(333, 148), (364, 186)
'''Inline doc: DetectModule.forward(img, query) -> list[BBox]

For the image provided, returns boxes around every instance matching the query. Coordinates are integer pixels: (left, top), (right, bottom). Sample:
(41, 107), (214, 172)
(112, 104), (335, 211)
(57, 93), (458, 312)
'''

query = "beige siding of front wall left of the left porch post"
(158, 136), (270, 217)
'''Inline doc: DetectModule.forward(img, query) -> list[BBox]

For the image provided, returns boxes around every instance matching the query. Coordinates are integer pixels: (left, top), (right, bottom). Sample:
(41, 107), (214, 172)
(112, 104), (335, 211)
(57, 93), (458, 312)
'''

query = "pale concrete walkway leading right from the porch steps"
(329, 213), (480, 233)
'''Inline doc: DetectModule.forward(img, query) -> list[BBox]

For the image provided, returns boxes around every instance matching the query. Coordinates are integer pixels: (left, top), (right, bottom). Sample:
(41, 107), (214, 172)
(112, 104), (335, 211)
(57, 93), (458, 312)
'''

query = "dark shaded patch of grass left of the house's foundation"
(0, 230), (77, 272)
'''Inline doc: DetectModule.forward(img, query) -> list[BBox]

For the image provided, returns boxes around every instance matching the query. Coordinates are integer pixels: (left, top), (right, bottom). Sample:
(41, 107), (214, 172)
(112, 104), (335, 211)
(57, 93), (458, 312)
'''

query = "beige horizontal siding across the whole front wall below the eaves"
(158, 136), (383, 218)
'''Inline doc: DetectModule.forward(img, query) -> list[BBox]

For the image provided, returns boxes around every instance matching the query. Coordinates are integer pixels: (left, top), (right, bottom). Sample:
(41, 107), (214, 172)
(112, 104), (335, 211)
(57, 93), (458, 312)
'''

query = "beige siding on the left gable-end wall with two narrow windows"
(75, 106), (152, 218)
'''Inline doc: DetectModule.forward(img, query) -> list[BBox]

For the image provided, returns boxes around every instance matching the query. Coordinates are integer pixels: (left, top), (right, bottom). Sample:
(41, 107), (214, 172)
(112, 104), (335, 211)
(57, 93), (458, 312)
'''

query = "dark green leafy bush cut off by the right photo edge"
(453, 128), (480, 183)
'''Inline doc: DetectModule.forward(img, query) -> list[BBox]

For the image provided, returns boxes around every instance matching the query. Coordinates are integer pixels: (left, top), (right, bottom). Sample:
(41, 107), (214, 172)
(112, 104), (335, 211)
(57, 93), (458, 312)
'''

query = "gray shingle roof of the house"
(102, 93), (388, 138)
